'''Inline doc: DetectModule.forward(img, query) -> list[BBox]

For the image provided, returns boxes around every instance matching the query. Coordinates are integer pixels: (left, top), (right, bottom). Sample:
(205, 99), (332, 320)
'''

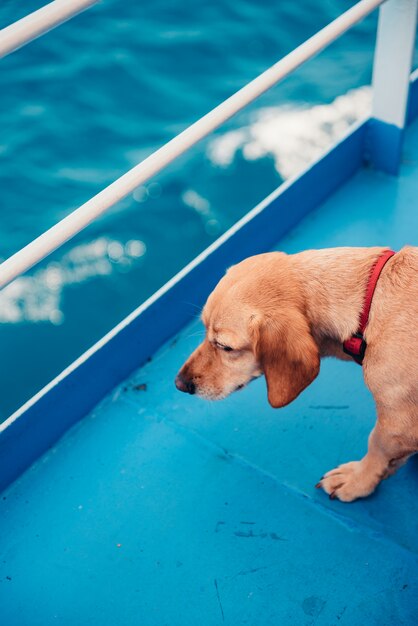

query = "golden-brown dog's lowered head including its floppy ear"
(176, 252), (319, 407)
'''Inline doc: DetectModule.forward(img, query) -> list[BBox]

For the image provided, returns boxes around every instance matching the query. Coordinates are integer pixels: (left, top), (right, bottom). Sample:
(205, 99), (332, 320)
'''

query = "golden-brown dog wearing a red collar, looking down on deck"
(176, 247), (418, 502)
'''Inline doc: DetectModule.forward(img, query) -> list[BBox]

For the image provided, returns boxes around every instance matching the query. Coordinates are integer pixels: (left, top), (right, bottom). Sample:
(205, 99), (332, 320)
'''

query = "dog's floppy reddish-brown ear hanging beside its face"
(253, 309), (320, 408)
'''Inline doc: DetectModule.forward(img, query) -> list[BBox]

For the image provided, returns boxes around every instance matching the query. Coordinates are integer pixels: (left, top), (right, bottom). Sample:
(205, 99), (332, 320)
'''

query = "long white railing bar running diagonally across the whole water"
(0, 0), (417, 288)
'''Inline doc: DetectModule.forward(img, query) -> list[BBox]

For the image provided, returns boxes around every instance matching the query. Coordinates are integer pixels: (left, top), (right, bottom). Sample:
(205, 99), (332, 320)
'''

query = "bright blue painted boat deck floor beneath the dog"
(0, 119), (418, 626)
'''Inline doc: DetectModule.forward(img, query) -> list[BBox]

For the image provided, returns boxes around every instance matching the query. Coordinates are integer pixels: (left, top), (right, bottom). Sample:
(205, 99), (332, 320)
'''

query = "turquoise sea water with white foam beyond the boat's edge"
(0, 0), (386, 419)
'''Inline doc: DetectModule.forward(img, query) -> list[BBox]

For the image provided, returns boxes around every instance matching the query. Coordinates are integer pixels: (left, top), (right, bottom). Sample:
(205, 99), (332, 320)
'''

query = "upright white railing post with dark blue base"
(365, 0), (418, 174)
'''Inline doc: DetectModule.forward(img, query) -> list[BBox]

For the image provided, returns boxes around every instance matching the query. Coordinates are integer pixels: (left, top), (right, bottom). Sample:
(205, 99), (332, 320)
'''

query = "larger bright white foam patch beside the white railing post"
(207, 87), (371, 178)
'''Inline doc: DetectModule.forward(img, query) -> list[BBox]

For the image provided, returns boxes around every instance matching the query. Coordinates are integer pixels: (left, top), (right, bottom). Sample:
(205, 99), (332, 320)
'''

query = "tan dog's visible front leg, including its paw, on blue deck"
(317, 412), (418, 502)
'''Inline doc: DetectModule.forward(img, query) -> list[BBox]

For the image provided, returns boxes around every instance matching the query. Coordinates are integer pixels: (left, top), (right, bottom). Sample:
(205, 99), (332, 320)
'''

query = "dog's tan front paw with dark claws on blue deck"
(315, 461), (379, 502)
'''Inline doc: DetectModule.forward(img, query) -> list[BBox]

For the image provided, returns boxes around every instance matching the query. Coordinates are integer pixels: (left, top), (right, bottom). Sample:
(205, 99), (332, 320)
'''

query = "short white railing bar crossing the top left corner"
(0, 0), (99, 58)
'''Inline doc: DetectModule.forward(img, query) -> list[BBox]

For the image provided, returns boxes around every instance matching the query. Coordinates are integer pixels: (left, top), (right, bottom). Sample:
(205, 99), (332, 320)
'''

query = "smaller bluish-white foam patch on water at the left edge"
(0, 237), (146, 324)
